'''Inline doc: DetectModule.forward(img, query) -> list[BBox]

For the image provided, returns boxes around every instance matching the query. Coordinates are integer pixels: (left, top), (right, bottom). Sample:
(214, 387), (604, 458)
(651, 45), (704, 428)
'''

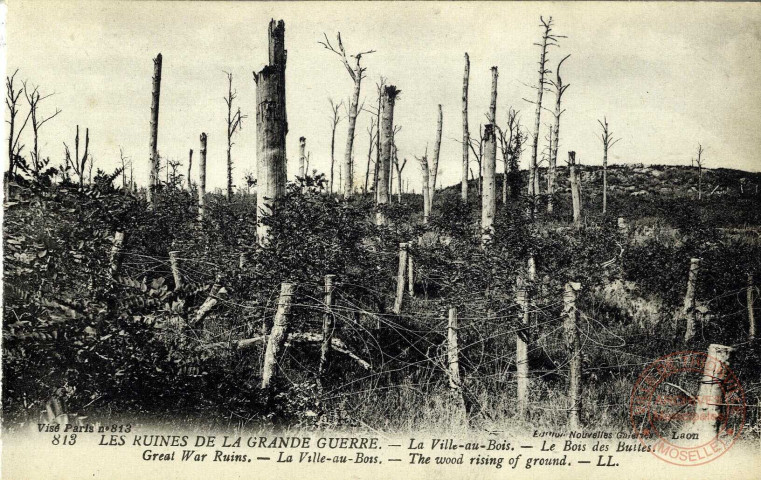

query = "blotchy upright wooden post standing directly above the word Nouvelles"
(563, 282), (581, 430)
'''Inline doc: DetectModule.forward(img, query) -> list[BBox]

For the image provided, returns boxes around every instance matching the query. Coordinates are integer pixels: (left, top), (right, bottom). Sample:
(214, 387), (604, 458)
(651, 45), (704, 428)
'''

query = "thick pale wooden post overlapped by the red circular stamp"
(690, 344), (734, 441)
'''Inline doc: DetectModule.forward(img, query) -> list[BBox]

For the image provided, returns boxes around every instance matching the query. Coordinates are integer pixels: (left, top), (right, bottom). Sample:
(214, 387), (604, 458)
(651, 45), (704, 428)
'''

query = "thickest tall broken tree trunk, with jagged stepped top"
(254, 19), (288, 245)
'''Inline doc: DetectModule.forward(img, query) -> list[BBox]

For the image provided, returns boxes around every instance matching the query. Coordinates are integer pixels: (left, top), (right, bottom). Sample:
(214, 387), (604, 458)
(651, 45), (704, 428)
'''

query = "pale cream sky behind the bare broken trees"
(3, 0), (761, 191)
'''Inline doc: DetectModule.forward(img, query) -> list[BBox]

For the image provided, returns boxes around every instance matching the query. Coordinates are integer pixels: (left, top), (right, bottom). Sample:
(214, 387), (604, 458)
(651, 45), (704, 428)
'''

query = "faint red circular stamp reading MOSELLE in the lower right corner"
(629, 345), (746, 466)
